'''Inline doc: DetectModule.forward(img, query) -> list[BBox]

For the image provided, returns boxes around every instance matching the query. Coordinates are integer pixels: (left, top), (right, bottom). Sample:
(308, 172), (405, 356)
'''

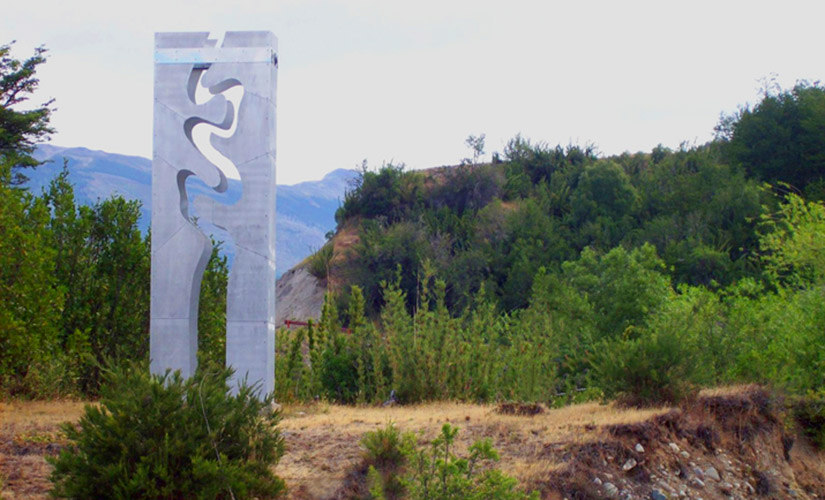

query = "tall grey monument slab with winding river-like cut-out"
(150, 31), (278, 395)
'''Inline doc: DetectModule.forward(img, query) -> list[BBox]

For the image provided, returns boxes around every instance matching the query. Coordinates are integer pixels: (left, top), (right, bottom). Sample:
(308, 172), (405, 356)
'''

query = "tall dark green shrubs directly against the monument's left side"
(42, 165), (151, 395)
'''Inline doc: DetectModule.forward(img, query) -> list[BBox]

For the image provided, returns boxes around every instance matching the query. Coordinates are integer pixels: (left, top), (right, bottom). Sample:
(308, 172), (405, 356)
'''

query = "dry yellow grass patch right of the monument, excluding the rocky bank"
(277, 403), (668, 498)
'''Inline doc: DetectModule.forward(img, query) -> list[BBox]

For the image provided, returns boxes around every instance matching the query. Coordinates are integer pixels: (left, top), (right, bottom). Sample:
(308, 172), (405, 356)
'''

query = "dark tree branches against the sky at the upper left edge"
(0, 42), (53, 184)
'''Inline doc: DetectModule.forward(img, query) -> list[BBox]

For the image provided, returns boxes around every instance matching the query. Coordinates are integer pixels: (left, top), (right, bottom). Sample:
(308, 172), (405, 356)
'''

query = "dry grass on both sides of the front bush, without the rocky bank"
(0, 401), (666, 499)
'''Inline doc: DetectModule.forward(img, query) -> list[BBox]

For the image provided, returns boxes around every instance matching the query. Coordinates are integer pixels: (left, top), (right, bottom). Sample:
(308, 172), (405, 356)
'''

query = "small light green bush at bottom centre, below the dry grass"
(402, 424), (538, 500)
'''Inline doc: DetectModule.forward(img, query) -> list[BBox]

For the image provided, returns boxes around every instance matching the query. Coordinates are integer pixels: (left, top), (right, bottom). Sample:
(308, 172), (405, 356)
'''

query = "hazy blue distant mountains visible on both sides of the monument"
(26, 144), (358, 276)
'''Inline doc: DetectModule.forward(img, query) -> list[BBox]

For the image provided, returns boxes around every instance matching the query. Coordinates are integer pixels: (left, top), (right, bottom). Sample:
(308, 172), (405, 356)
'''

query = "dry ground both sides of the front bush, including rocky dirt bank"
(0, 388), (825, 500)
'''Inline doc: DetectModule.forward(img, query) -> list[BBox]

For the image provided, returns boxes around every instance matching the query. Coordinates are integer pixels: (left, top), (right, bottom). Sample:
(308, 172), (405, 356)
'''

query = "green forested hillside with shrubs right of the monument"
(278, 82), (825, 412)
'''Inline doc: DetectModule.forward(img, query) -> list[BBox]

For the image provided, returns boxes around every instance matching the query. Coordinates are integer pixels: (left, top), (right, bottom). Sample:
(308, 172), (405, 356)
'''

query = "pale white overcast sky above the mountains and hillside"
(0, 0), (825, 184)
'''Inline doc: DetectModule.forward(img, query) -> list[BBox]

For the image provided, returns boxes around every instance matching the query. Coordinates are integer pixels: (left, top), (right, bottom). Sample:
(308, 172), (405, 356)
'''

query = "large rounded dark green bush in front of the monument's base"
(51, 365), (284, 498)
